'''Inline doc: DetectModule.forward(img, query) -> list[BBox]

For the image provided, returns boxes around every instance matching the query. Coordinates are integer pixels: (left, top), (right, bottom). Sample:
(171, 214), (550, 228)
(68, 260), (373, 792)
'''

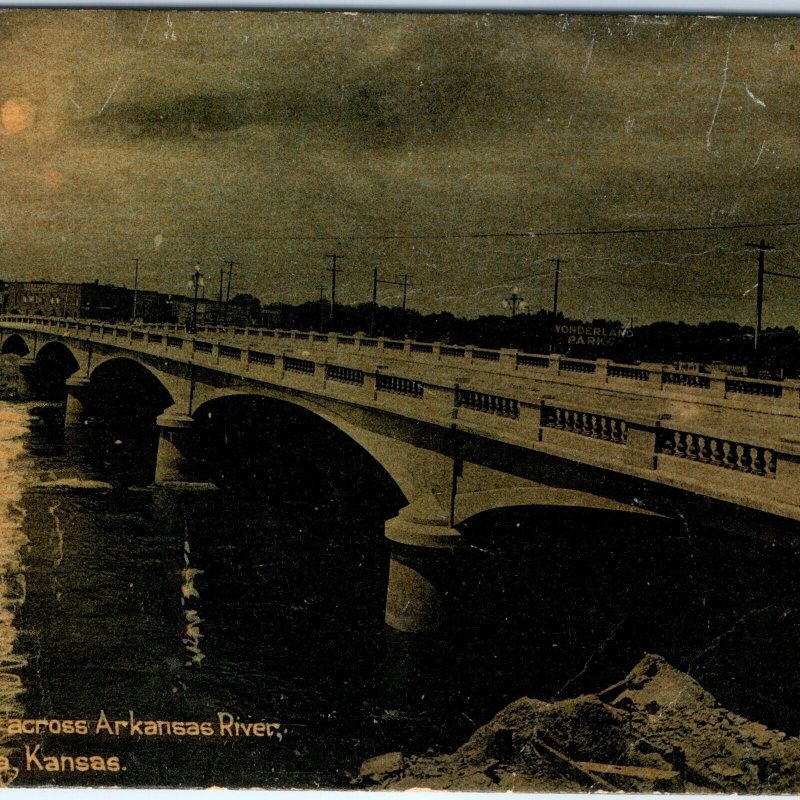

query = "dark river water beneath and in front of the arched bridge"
(0, 396), (800, 788)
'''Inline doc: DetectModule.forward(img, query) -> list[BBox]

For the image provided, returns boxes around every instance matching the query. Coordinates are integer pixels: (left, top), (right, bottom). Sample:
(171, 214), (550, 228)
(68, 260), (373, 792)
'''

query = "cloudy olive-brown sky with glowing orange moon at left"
(0, 11), (800, 324)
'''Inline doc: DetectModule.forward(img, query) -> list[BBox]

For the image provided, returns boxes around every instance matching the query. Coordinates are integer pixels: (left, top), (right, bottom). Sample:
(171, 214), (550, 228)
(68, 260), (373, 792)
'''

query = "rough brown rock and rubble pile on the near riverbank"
(356, 655), (800, 793)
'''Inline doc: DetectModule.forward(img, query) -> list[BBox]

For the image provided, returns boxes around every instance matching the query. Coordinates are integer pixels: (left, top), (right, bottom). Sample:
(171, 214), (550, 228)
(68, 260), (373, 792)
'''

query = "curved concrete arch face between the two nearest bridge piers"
(192, 387), (416, 503)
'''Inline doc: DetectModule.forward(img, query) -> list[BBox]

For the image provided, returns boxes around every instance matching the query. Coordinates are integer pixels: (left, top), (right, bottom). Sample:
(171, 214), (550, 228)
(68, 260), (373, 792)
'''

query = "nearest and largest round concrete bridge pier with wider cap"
(385, 514), (461, 633)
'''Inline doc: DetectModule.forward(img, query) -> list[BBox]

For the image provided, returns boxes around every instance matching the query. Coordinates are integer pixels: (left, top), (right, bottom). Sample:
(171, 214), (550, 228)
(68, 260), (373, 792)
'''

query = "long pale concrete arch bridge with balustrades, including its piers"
(0, 317), (800, 630)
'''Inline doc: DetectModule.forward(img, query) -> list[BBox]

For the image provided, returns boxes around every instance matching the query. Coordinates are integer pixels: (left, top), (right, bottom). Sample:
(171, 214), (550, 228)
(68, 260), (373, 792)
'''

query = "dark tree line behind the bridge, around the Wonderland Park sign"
(263, 302), (800, 377)
